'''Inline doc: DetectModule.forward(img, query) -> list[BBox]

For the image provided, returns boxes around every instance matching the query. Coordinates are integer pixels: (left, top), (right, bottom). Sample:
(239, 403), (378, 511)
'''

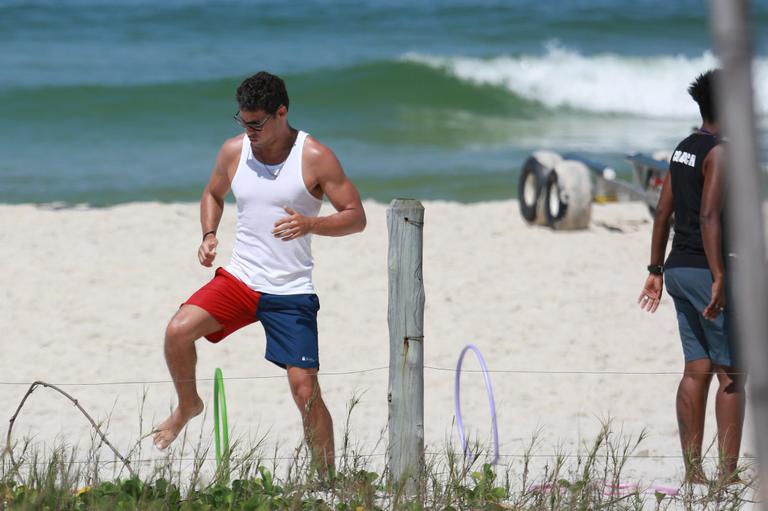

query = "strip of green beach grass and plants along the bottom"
(0, 397), (757, 511)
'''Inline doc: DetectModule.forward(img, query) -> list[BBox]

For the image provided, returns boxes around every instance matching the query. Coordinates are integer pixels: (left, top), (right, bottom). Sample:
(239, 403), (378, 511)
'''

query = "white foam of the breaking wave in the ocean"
(402, 43), (768, 118)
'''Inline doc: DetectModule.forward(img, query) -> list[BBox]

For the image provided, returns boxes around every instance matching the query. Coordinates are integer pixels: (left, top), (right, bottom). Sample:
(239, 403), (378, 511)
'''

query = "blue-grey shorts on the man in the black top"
(664, 268), (736, 367)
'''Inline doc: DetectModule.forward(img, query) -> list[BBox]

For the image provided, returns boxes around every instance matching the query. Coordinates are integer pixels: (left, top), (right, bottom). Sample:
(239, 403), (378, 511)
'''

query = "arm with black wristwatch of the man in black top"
(637, 172), (674, 312)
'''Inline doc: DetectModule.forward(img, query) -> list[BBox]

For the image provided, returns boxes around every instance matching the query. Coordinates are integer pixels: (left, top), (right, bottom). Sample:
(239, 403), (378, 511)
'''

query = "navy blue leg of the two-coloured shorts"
(256, 293), (320, 369)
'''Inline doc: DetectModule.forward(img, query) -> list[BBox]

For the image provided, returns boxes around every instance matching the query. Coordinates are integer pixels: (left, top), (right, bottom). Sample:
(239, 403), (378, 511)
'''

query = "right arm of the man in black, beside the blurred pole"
(699, 145), (725, 319)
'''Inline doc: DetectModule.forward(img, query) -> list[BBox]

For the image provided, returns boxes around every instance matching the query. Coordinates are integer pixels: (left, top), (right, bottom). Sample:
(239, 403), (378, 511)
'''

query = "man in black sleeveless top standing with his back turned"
(638, 70), (745, 484)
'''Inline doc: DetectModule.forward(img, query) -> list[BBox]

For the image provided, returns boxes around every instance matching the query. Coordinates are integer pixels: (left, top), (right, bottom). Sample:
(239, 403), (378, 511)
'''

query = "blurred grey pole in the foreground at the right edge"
(711, 0), (768, 511)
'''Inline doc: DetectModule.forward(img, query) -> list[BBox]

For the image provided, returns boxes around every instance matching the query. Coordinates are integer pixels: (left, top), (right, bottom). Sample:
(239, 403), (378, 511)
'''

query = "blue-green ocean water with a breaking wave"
(0, 0), (768, 205)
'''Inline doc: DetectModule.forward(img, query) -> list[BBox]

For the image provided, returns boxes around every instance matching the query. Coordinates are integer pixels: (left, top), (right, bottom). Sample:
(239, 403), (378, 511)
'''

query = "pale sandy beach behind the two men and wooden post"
(0, 201), (755, 496)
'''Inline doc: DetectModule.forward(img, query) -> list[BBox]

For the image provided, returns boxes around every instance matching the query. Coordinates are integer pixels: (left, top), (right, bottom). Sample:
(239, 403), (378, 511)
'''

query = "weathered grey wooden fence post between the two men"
(387, 199), (424, 496)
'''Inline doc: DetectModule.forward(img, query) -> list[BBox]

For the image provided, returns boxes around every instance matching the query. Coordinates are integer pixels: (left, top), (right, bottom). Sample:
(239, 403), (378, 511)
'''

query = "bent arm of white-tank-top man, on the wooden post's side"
(305, 139), (366, 236)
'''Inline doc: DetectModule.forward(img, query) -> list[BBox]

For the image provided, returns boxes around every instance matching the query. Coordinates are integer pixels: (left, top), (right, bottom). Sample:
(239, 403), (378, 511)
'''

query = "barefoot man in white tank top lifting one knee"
(154, 71), (366, 471)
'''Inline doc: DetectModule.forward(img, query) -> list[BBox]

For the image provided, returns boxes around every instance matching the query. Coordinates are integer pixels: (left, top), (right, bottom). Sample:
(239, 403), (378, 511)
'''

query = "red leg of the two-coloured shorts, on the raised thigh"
(182, 268), (261, 342)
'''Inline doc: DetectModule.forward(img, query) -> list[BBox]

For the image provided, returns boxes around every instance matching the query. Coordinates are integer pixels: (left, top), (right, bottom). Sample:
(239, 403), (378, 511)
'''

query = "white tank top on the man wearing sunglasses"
(226, 131), (323, 295)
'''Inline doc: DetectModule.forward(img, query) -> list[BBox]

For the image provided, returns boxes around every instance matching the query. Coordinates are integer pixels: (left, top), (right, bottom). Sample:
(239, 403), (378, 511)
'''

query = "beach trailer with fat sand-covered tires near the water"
(517, 151), (670, 230)
